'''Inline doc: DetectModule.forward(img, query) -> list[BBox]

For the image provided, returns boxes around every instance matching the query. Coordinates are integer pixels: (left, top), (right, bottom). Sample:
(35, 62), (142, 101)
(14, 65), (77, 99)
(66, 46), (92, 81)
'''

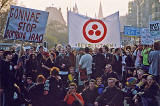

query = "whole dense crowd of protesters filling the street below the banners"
(0, 42), (160, 106)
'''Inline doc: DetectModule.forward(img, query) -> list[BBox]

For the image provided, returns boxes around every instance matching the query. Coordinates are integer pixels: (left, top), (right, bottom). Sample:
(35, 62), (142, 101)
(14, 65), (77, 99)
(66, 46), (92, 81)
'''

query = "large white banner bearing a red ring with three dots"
(68, 12), (120, 48)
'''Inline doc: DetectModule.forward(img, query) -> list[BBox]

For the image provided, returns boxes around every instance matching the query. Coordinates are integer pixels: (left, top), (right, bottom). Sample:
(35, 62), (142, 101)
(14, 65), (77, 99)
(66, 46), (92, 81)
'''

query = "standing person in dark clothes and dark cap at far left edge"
(0, 51), (16, 106)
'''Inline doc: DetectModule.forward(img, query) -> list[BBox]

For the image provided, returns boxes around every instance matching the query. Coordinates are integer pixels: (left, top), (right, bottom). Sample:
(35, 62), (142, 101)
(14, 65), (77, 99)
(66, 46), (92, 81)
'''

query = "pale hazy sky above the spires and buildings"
(18, 0), (132, 20)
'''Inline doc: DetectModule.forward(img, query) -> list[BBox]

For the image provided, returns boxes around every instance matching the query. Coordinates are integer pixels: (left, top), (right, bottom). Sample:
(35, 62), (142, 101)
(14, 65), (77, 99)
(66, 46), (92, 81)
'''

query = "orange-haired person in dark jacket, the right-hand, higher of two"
(44, 68), (65, 106)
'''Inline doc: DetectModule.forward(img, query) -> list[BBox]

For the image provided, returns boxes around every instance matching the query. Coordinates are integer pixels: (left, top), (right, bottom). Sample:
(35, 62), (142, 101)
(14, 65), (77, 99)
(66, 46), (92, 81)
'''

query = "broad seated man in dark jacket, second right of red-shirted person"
(94, 78), (124, 106)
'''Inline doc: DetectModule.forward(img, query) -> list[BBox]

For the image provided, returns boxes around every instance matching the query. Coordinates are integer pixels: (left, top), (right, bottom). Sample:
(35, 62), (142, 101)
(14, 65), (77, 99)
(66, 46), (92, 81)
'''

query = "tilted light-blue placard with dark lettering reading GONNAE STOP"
(4, 6), (48, 43)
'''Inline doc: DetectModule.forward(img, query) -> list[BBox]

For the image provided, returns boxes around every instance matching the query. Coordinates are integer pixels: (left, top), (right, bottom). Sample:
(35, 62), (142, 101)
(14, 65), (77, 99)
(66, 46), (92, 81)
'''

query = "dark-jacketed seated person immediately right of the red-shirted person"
(82, 79), (98, 106)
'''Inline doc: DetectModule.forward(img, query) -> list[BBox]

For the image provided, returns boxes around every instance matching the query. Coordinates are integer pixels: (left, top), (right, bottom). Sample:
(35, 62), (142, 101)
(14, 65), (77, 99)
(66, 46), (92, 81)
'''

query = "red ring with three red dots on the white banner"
(83, 19), (107, 43)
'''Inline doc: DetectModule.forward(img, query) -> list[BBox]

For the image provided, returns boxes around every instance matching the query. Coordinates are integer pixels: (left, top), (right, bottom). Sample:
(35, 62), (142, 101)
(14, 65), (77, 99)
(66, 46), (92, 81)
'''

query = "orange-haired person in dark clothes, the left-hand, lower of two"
(29, 75), (45, 106)
